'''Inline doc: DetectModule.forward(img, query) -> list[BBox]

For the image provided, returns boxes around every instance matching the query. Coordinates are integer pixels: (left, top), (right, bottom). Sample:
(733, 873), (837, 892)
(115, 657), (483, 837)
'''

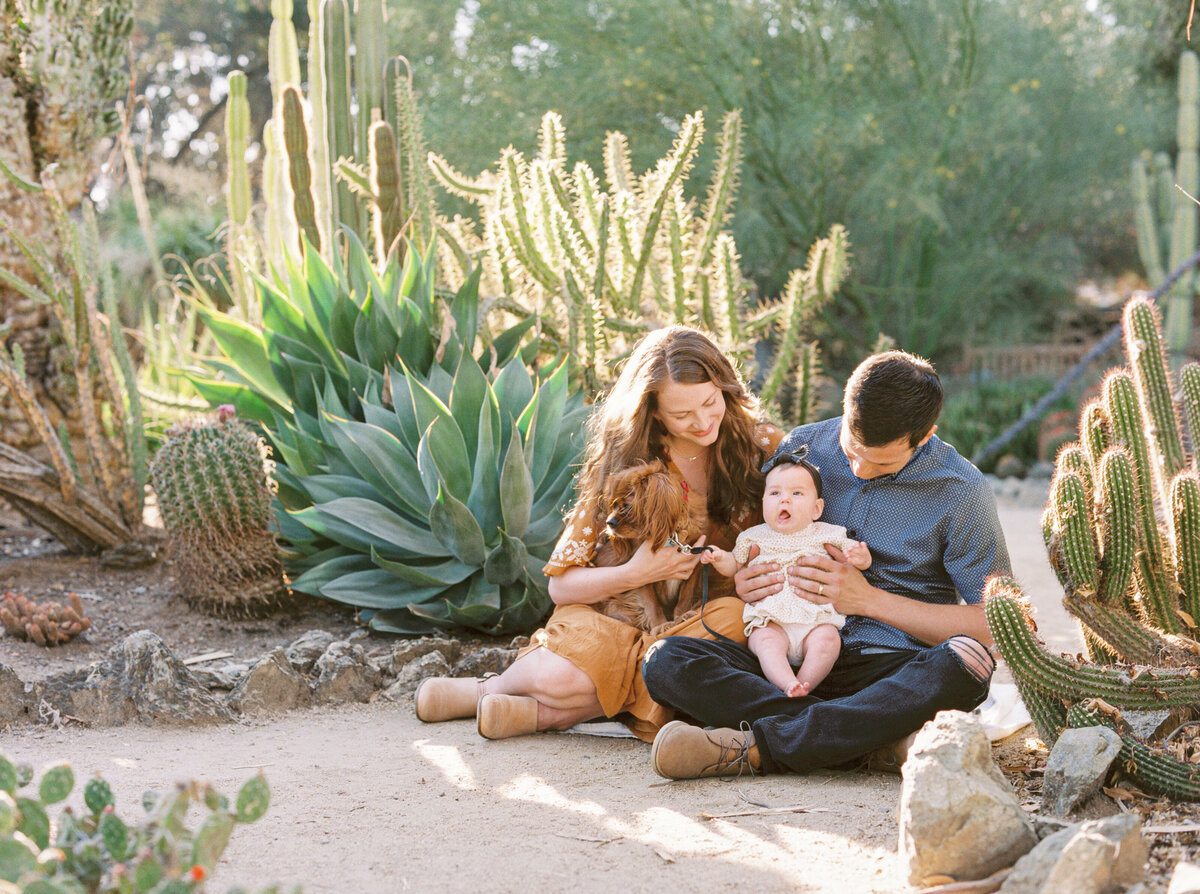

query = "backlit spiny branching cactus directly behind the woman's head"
(430, 112), (847, 410)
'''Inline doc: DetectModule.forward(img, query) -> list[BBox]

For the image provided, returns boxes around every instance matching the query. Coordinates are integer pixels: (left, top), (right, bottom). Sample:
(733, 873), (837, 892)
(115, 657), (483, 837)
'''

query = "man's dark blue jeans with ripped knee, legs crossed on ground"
(642, 636), (989, 773)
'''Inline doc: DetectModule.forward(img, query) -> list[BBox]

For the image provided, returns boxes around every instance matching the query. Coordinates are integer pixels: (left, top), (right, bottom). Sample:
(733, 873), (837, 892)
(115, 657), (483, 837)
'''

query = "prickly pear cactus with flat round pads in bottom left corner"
(0, 754), (270, 894)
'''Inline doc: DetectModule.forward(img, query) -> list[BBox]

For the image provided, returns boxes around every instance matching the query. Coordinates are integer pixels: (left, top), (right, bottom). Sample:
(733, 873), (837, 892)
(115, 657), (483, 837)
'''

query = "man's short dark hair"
(842, 350), (943, 448)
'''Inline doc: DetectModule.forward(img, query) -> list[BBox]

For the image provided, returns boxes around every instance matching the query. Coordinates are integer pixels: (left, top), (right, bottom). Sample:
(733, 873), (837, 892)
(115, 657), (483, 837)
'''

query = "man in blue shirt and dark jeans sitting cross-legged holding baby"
(642, 350), (1009, 779)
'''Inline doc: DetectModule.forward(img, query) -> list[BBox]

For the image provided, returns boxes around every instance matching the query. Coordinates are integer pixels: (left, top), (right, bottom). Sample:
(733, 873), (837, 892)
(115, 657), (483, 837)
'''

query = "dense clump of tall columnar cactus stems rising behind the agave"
(253, 0), (432, 265)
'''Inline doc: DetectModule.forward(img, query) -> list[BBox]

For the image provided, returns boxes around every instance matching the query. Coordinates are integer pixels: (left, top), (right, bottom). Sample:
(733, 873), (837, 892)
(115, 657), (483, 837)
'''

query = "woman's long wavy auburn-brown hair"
(577, 325), (762, 526)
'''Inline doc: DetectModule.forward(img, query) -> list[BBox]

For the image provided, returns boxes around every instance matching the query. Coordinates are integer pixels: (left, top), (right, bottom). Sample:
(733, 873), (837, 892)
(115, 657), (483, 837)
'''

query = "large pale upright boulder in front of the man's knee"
(900, 710), (1038, 884)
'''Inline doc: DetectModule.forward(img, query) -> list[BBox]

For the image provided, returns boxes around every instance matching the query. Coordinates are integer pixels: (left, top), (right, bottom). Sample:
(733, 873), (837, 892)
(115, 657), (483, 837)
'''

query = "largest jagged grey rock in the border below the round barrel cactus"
(43, 630), (233, 726)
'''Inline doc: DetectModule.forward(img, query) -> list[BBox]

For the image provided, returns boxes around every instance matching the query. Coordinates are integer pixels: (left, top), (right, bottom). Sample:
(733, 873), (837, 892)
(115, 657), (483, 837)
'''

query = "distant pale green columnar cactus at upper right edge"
(1133, 49), (1200, 368)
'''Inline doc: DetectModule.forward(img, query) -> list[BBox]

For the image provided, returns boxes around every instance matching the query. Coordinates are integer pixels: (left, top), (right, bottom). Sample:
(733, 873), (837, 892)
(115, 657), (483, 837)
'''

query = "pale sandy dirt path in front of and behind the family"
(0, 508), (1080, 894)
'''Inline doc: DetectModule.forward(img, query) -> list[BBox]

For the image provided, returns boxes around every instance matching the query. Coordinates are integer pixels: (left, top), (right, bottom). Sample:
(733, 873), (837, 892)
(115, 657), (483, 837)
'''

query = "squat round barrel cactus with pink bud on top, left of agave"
(150, 407), (287, 617)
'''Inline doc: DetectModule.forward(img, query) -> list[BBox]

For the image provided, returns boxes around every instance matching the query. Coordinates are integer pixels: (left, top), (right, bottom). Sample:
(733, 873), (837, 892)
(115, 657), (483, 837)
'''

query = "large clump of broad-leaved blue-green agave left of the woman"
(198, 238), (586, 632)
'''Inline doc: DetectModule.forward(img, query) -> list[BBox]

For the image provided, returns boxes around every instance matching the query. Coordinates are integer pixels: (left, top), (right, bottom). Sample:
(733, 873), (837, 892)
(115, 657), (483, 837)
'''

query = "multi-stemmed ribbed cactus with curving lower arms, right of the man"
(985, 298), (1200, 800)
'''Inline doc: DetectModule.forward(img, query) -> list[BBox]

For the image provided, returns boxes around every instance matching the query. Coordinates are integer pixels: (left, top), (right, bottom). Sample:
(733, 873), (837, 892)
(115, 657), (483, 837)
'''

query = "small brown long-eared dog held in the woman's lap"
(594, 460), (700, 635)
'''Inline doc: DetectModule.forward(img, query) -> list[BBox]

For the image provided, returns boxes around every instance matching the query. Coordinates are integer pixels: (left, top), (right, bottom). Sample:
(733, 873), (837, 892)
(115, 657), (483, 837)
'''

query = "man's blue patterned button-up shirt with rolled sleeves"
(779, 416), (1010, 649)
